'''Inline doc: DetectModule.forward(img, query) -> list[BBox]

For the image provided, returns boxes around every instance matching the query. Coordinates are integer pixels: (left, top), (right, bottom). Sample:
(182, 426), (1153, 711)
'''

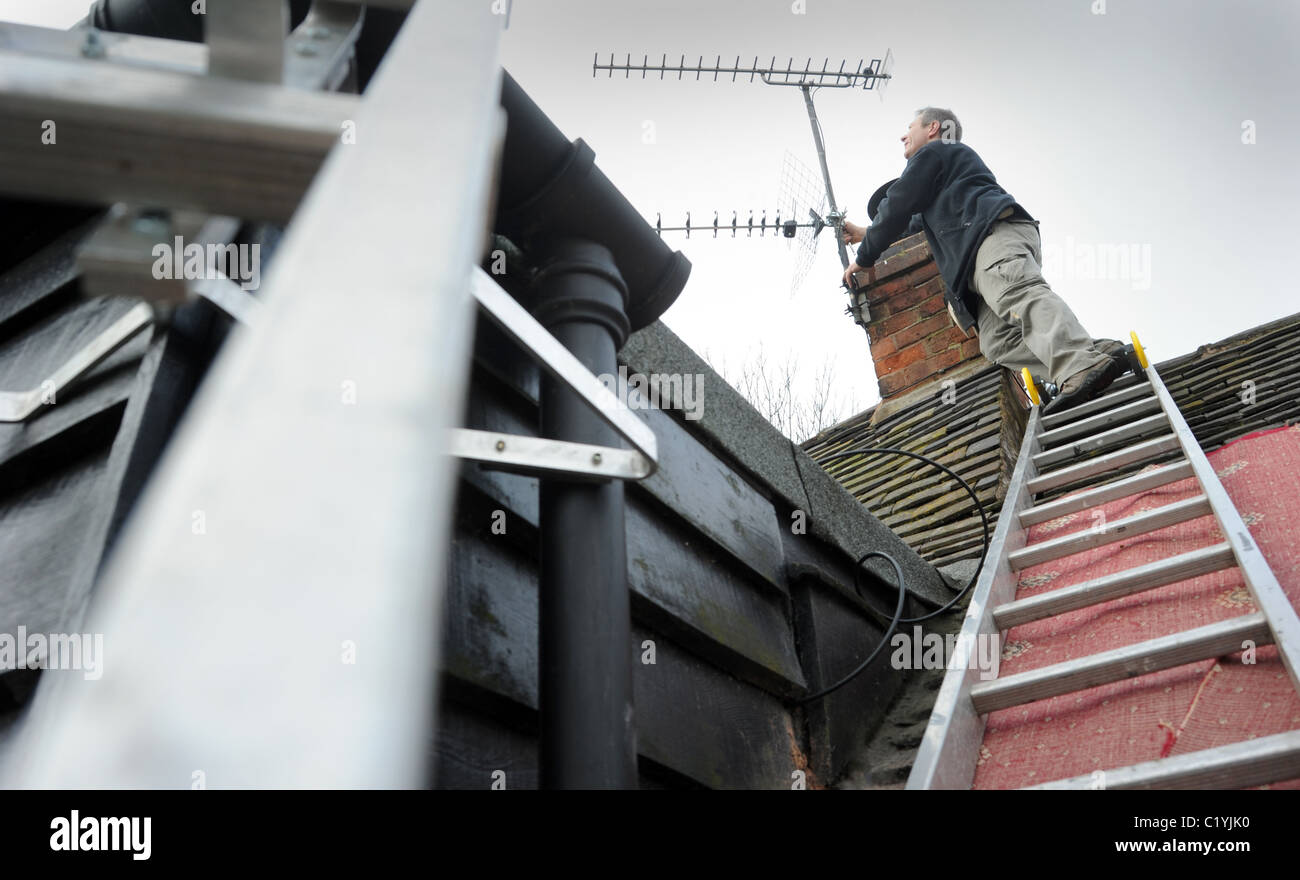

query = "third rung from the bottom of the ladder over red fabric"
(993, 541), (1236, 630)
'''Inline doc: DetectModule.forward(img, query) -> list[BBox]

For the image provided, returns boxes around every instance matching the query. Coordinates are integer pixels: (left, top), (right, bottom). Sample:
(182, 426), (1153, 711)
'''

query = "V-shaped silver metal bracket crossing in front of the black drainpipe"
(449, 266), (659, 480)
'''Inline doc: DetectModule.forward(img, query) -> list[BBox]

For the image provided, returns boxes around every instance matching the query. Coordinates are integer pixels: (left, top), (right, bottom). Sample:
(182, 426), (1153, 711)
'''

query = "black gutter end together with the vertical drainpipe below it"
(495, 73), (690, 788)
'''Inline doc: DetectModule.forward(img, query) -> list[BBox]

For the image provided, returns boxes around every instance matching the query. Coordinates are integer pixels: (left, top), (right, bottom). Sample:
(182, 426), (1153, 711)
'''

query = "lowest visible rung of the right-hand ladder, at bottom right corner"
(1030, 731), (1300, 790)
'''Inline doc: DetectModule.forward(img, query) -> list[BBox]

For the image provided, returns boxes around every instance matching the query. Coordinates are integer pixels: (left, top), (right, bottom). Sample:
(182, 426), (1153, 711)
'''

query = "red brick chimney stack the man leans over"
(849, 233), (989, 413)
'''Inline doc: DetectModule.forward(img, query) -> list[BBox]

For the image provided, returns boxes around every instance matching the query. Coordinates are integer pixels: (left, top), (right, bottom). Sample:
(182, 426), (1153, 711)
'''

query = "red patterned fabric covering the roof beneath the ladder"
(974, 425), (1300, 789)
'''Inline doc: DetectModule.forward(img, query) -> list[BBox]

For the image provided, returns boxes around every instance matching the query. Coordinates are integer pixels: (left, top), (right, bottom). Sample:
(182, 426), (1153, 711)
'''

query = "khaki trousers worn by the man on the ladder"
(971, 220), (1106, 385)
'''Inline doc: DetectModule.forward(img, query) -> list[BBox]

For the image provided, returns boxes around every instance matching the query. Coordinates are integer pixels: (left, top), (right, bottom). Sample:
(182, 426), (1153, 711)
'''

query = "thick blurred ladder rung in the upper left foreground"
(0, 49), (360, 221)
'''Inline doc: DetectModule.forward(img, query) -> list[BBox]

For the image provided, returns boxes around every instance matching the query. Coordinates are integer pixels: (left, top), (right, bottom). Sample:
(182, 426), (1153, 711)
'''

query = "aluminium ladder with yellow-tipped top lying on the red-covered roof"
(907, 335), (1300, 789)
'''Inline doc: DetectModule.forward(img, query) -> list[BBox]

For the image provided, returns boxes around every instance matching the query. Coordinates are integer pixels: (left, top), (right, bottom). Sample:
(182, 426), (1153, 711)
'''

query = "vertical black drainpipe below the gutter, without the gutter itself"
(532, 239), (637, 789)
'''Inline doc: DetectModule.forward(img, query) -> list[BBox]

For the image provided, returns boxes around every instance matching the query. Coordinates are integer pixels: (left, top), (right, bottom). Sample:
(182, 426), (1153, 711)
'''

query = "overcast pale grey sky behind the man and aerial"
(0, 0), (1300, 431)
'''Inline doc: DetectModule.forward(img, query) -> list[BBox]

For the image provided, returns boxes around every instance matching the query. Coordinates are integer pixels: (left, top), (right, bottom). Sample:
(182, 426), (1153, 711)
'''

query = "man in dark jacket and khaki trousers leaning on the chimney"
(844, 107), (1126, 415)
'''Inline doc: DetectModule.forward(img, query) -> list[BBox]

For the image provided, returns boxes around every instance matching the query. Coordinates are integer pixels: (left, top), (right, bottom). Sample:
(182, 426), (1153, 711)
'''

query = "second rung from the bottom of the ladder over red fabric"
(971, 614), (1273, 715)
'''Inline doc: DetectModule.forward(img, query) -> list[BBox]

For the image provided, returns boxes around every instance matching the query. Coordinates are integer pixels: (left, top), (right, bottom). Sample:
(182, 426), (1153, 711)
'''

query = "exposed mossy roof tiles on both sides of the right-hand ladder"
(802, 315), (1300, 565)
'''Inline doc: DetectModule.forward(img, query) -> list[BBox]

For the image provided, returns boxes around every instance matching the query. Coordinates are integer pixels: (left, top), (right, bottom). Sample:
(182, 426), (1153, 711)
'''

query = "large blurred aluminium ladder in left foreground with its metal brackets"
(0, 0), (658, 788)
